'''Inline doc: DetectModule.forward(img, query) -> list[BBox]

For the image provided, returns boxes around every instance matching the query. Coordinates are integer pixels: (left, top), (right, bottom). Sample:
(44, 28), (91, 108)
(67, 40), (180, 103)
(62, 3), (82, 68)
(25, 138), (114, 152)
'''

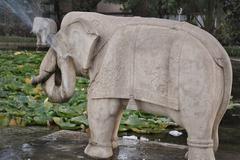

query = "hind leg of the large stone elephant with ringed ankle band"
(180, 99), (217, 160)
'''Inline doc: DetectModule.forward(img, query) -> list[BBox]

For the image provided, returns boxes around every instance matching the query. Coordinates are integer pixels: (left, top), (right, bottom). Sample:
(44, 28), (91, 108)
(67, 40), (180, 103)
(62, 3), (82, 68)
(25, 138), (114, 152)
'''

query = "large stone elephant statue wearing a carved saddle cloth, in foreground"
(32, 12), (232, 160)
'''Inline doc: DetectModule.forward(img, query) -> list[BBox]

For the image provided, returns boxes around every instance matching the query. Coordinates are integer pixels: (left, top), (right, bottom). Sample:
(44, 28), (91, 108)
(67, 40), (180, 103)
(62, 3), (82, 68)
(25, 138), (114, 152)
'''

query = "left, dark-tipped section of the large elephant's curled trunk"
(32, 48), (57, 85)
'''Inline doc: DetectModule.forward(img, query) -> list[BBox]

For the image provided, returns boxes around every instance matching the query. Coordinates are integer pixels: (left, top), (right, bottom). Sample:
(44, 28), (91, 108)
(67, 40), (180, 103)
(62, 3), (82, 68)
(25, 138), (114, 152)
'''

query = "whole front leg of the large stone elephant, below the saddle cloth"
(84, 99), (120, 158)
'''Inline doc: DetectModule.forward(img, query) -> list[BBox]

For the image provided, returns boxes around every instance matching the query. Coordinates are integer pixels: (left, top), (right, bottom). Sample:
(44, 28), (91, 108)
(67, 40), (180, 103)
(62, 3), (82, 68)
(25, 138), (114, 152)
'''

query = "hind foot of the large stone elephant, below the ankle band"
(185, 147), (215, 160)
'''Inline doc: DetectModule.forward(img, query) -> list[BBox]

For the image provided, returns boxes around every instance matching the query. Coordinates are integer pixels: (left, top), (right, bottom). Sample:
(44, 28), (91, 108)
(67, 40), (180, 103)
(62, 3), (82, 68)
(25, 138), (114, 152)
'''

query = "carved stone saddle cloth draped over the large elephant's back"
(89, 25), (184, 110)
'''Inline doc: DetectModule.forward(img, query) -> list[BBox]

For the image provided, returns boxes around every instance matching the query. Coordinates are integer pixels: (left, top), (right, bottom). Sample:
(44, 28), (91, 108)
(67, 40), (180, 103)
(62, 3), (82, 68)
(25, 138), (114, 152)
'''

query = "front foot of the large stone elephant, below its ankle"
(84, 143), (113, 159)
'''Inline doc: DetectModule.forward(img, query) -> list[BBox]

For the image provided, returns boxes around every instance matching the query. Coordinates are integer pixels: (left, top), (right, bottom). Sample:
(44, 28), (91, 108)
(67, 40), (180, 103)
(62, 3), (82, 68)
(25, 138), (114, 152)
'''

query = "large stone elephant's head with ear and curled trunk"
(32, 19), (99, 103)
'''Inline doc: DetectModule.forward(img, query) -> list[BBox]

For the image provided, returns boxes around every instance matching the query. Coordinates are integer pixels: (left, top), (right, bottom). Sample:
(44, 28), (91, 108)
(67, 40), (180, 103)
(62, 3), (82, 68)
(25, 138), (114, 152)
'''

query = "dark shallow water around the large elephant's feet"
(0, 125), (240, 160)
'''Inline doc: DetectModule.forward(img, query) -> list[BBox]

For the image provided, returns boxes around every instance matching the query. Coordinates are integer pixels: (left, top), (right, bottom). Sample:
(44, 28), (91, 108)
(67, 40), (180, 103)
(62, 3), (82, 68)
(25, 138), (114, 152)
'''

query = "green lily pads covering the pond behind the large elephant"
(0, 51), (175, 133)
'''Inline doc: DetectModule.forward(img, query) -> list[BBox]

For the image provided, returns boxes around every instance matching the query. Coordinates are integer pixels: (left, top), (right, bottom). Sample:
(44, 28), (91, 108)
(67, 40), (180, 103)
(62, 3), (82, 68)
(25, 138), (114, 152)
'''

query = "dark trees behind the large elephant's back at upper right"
(104, 0), (240, 45)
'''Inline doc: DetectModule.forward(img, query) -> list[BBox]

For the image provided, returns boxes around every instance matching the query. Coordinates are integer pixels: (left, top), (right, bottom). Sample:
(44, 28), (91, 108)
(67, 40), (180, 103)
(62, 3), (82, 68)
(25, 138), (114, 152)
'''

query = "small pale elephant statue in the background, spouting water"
(31, 17), (57, 46)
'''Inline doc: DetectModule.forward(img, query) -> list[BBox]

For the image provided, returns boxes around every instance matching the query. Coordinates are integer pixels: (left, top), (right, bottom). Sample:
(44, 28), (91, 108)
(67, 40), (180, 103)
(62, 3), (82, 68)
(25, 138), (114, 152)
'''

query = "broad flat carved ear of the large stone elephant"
(62, 19), (99, 69)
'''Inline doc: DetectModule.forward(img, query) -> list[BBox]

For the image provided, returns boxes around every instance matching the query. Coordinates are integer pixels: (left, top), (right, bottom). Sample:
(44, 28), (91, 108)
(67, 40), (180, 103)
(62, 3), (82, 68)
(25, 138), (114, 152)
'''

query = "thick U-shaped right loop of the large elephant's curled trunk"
(43, 57), (76, 103)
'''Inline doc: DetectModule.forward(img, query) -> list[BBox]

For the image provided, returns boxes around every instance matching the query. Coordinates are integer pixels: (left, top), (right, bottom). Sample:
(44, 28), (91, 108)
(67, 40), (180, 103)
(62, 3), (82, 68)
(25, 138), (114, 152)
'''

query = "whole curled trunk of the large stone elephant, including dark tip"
(32, 48), (76, 103)
